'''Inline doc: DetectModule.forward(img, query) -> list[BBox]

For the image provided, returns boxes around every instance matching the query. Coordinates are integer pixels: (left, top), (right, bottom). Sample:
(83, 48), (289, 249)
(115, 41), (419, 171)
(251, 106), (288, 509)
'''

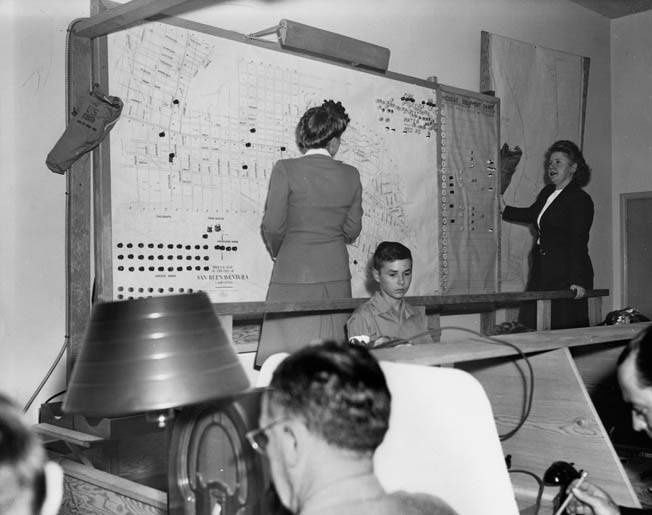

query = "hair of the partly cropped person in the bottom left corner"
(0, 394), (46, 514)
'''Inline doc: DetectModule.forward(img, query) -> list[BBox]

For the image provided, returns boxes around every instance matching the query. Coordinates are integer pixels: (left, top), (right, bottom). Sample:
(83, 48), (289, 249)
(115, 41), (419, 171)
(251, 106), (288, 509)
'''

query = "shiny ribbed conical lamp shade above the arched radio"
(63, 293), (249, 417)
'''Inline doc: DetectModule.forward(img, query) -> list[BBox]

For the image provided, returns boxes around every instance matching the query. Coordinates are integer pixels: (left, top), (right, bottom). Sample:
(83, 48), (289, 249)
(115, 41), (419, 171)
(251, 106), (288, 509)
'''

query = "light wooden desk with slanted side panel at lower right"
(374, 322), (650, 514)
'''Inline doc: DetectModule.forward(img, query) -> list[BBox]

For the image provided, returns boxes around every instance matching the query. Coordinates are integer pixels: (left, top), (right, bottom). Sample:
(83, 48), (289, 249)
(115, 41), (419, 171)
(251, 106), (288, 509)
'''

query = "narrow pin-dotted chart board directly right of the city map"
(438, 85), (500, 293)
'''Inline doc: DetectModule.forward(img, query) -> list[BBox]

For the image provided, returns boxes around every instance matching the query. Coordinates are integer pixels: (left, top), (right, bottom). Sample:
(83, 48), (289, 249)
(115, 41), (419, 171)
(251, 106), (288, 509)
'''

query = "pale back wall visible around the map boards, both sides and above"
(0, 0), (612, 420)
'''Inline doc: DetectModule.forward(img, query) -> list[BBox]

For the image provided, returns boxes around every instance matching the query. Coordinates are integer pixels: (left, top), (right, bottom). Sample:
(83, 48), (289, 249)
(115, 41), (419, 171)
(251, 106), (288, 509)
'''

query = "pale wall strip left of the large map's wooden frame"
(0, 0), (89, 422)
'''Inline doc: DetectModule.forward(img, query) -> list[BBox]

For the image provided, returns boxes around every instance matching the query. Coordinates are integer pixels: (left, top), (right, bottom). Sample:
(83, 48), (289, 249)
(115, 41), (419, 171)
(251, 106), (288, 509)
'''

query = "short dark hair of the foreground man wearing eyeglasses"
(269, 341), (391, 452)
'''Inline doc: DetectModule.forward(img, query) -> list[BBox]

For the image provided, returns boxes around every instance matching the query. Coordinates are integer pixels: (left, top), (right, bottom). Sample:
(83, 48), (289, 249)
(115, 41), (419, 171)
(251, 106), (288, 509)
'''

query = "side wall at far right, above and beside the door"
(611, 11), (652, 308)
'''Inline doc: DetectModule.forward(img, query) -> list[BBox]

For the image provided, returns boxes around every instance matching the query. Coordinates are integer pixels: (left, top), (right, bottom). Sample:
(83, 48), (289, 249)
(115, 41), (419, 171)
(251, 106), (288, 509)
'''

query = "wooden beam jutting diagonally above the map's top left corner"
(72, 0), (199, 38)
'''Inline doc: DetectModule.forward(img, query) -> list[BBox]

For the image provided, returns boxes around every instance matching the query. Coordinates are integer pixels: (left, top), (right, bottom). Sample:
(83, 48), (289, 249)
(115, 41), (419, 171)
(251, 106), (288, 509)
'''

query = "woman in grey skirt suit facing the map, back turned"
(256, 100), (362, 366)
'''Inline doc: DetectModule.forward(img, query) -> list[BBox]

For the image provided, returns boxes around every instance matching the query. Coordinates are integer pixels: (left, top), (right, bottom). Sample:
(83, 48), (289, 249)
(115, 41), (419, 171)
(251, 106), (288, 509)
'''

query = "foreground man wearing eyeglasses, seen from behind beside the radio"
(247, 342), (455, 515)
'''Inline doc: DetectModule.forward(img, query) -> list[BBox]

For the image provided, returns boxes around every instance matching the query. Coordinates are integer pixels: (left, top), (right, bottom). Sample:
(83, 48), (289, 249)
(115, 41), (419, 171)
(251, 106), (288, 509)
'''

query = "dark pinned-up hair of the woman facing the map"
(296, 100), (351, 151)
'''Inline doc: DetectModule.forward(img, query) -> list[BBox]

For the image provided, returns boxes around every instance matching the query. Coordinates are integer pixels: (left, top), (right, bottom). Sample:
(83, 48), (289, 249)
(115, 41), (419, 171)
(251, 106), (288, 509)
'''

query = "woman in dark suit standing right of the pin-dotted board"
(501, 140), (593, 329)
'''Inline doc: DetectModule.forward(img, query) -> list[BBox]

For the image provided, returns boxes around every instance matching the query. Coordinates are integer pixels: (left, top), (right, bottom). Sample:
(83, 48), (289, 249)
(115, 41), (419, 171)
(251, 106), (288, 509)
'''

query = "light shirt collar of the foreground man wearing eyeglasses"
(300, 473), (385, 515)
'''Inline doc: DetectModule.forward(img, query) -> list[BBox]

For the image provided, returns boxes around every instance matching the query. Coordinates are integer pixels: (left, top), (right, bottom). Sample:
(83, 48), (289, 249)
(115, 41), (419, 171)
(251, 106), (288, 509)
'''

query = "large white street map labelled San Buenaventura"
(108, 23), (440, 302)
